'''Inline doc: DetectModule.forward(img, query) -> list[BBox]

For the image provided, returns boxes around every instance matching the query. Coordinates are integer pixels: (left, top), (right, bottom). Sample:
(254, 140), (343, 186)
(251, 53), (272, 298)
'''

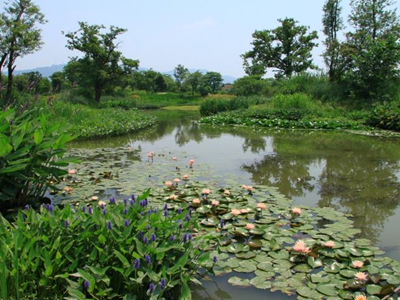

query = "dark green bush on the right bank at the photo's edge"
(367, 102), (400, 131)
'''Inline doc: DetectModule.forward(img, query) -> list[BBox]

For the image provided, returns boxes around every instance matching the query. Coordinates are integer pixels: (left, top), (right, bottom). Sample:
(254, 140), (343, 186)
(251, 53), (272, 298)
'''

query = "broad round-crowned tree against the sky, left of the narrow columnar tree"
(242, 18), (318, 78)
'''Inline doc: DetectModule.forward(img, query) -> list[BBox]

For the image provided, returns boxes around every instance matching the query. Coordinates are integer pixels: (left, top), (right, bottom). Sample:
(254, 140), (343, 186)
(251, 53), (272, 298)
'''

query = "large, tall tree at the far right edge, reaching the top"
(342, 0), (400, 101)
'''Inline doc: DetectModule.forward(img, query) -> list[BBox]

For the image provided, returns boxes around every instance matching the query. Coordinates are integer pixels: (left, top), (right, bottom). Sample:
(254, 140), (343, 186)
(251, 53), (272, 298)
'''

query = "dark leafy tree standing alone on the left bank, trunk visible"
(65, 22), (139, 102)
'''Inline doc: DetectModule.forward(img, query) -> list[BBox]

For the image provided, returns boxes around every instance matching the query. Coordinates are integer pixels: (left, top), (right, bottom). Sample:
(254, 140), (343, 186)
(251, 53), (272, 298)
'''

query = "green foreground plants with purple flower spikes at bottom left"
(0, 191), (210, 300)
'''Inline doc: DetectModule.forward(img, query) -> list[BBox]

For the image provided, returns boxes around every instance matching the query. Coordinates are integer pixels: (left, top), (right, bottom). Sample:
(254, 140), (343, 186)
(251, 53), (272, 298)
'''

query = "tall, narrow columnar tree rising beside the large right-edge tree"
(322, 0), (344, 81)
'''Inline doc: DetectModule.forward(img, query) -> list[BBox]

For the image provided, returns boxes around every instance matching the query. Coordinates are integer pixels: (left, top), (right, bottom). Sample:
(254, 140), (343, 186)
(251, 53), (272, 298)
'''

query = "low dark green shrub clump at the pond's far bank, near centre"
(200, 97), (250, 116)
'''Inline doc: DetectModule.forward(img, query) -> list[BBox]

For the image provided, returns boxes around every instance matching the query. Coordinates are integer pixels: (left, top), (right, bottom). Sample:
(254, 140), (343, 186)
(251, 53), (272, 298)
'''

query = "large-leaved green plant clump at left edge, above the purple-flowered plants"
(0, 110), (73, 210)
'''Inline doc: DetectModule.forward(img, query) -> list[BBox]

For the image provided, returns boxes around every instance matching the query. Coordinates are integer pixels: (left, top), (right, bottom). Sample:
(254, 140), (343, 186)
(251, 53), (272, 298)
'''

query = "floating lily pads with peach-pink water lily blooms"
(56, 149), (400, 300)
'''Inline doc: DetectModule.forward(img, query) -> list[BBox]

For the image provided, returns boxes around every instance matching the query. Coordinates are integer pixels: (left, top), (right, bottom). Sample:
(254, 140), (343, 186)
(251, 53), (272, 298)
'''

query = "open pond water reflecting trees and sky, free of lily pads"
(72, 110), (400, 300)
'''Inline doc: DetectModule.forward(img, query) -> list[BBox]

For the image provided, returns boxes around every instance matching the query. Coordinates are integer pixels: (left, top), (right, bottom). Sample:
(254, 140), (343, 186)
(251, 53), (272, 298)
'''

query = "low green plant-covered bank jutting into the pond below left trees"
(40, 101), (156, 138)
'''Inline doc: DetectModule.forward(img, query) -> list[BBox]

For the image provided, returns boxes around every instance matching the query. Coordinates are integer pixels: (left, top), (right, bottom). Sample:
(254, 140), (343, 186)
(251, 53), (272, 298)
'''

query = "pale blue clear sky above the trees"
(0, 0), (400, 77)
